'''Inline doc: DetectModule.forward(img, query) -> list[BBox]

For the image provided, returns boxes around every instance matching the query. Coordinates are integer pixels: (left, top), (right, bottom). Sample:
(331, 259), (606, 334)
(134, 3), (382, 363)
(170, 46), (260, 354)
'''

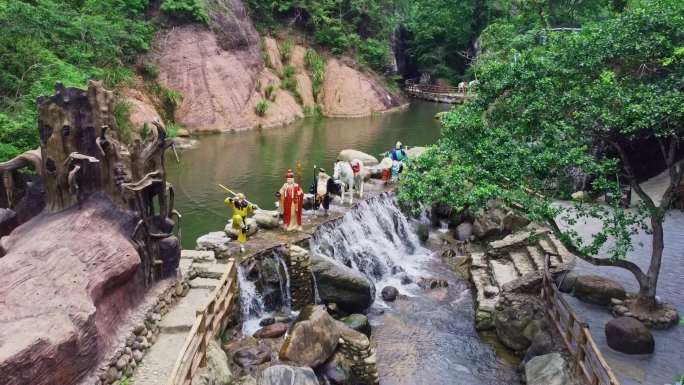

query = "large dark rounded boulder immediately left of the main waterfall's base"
(311, 255), (374, 313)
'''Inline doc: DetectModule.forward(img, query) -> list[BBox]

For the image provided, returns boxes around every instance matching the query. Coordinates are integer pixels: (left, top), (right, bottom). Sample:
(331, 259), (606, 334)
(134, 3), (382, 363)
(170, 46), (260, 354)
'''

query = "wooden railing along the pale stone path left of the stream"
(166, 261), (238, 385)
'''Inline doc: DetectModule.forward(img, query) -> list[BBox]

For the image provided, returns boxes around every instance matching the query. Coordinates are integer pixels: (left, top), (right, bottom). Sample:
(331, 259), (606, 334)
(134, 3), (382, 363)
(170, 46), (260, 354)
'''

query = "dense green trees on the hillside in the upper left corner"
(0, 0), (154, 161)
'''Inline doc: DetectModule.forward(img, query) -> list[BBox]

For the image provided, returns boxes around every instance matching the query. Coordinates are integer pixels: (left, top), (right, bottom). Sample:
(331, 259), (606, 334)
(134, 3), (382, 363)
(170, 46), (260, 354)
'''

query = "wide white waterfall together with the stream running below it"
(311, 197), (518, 385)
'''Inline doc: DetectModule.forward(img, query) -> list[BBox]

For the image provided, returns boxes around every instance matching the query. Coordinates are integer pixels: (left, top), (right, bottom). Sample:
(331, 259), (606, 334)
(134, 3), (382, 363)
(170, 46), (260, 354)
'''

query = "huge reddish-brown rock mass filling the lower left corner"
(0, 194), (147, 385)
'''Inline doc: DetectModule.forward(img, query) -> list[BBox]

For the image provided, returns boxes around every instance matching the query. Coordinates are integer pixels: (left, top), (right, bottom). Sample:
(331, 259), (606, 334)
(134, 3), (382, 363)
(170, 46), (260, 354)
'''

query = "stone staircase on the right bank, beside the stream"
(470, 226), (576, 330)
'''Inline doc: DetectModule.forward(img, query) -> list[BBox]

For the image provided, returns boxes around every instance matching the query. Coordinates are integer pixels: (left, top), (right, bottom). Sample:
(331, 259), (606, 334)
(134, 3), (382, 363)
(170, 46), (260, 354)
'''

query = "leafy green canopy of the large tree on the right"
(401, 0), (684, 276)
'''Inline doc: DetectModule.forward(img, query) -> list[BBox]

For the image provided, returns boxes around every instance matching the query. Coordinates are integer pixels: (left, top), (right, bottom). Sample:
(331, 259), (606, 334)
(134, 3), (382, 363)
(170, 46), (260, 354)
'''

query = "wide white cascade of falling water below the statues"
(310, 195), (430, 291)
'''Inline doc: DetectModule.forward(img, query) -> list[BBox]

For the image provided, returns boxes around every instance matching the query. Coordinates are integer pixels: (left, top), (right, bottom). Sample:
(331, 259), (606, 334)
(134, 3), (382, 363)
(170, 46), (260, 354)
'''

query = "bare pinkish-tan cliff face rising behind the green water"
(153, 0), (401, 132)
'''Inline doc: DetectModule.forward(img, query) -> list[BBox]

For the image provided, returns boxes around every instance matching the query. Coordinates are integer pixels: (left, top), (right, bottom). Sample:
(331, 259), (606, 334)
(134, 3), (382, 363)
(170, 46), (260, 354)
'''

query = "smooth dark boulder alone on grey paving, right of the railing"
(605, 317), (655, 354)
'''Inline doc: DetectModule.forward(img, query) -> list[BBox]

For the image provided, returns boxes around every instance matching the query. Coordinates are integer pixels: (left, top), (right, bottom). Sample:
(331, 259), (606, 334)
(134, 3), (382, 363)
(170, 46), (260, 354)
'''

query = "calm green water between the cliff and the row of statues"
(166, 101), (449, 248)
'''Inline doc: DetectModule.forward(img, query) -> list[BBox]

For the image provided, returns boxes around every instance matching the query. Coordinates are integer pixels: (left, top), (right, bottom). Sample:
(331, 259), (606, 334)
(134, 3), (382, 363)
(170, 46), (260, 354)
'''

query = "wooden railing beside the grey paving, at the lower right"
(542, 253), (620, 385)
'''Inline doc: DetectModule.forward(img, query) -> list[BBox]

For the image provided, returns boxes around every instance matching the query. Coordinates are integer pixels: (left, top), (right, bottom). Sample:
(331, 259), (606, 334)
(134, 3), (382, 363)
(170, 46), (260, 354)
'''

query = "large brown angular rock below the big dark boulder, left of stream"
(280, 305), (339, 368)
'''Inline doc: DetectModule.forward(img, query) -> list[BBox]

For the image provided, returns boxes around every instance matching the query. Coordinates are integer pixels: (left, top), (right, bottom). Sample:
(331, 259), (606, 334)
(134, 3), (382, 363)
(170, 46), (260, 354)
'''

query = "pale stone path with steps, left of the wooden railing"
(132, 250), (227, 385)
